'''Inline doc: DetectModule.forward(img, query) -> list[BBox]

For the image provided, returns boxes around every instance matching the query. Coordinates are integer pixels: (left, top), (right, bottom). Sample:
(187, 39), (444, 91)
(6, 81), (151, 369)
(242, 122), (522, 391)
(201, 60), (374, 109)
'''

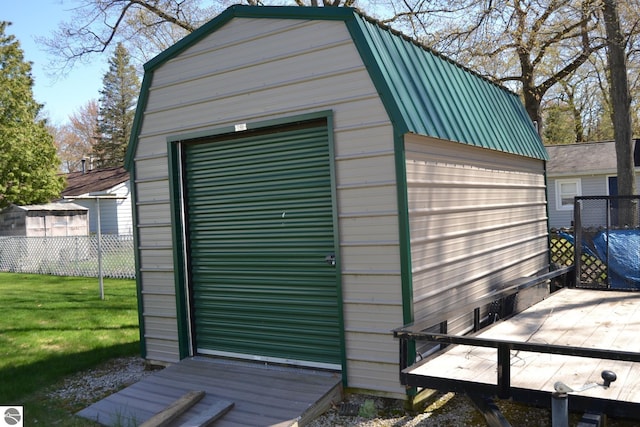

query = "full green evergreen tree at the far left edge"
(0, 22), (64, 208)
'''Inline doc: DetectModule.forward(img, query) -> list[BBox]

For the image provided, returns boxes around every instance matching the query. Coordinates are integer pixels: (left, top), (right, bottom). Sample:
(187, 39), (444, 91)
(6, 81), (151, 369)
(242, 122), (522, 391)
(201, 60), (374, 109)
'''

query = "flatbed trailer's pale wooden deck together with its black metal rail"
(396, 289), (640, 418)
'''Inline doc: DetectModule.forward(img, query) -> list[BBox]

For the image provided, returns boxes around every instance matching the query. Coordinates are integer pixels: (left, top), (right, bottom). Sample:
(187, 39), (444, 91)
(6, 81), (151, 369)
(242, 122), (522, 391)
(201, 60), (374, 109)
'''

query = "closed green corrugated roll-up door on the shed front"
(184, 121), (341, 365)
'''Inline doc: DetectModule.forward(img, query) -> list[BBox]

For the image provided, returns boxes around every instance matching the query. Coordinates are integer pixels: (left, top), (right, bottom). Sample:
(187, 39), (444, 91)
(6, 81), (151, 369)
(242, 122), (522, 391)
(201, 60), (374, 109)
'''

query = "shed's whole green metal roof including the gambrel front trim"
(126, 5), (548, 169)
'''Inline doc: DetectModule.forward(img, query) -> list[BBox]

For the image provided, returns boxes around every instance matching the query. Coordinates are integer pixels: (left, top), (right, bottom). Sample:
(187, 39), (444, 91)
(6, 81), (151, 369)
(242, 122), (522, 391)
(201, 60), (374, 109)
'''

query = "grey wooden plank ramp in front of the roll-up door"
(77, 357), (342, 427)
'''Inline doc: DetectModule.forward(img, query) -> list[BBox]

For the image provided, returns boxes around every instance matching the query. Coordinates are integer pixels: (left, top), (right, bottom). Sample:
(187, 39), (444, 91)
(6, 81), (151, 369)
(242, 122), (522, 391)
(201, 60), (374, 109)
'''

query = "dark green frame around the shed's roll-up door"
(167, 111), (346, 372)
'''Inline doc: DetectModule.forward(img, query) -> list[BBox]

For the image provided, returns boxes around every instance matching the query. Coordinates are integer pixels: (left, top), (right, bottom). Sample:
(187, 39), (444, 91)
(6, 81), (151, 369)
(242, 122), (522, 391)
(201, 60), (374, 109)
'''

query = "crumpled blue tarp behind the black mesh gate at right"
(593, 230), (640, 289)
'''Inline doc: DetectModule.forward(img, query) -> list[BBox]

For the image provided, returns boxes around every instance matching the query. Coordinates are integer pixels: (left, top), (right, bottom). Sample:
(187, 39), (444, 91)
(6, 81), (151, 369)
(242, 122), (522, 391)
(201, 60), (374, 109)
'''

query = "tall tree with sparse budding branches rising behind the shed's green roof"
(388, 0), (604, 135)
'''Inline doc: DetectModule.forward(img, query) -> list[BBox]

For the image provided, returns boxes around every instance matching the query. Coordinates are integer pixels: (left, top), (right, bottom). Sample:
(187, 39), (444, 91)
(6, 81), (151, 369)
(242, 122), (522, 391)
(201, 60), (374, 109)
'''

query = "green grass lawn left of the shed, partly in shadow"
(0, 273), (140, 425)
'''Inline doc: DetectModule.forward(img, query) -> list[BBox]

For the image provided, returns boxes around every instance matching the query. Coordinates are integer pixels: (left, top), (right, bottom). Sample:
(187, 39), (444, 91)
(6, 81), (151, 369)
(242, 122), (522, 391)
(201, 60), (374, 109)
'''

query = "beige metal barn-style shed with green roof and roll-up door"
(126, 6), (548, 398)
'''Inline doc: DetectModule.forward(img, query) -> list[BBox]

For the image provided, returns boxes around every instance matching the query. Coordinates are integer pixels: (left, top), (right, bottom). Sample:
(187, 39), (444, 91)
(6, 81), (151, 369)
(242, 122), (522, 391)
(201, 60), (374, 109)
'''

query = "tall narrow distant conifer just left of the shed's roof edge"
(93, 43), (140, 168)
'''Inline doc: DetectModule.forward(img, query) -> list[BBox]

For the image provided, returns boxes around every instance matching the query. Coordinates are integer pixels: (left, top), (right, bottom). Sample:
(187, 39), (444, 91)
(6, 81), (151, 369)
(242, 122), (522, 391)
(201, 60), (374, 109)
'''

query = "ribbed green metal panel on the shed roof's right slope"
(351, 15), (547, 159)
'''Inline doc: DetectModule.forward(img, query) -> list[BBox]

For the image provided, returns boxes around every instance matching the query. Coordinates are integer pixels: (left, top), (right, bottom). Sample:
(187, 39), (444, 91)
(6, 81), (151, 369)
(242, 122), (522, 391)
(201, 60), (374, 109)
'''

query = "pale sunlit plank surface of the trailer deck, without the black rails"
(406, 289), (640, 418)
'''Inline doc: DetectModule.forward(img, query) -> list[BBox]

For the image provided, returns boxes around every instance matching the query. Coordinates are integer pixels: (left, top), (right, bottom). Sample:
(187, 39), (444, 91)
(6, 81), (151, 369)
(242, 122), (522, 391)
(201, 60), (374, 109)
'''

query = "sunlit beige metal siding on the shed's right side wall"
(405, 136), (548, 330)
